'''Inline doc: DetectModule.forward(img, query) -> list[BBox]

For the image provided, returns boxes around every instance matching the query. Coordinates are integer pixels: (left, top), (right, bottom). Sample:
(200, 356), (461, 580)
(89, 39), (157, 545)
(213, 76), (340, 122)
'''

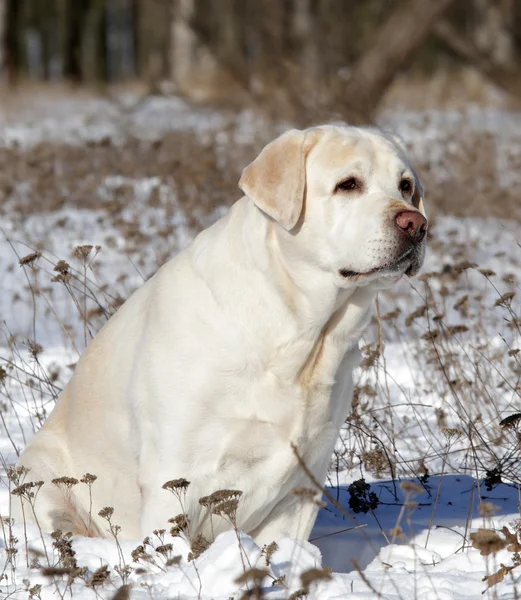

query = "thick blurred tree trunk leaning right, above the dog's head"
(344, 0), (454, 122)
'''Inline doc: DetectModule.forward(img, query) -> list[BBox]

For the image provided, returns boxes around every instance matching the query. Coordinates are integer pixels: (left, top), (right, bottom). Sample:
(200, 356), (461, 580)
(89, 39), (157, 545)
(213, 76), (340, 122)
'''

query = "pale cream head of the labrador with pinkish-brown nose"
(239, 125), (427, 287)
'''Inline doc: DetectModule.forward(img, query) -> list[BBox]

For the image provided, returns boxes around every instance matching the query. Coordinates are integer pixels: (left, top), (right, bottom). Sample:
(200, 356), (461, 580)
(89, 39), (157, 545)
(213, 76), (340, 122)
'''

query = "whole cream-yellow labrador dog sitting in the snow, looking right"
(13, 125), (427, 544)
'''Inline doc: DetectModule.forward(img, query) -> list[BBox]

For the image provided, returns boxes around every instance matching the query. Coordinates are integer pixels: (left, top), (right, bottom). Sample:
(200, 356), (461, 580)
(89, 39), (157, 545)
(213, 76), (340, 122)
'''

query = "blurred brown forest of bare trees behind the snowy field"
(0, 0), (521, 122)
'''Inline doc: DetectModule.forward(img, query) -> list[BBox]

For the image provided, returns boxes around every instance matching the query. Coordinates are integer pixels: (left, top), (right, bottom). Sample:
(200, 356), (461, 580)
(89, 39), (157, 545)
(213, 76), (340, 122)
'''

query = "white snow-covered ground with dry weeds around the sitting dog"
(0, 91), (521, 600)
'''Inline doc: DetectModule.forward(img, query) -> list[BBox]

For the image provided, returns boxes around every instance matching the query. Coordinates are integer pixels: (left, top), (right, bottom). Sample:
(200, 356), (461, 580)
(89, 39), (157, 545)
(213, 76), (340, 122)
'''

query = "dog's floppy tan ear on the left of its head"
(239, 129), (309, 231)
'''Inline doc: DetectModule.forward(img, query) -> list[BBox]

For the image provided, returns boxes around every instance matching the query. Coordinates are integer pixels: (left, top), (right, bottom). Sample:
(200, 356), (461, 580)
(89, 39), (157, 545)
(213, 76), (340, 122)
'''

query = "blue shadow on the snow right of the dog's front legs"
(310, 475), (519, 572)
